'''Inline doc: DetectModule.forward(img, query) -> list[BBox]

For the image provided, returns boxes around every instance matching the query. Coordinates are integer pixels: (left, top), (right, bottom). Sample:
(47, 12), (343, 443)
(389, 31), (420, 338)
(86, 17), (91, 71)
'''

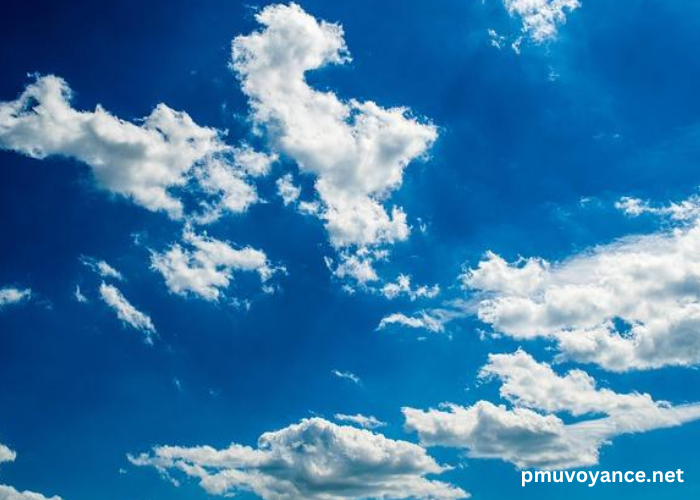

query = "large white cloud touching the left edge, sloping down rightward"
(0, 75), (224, 217)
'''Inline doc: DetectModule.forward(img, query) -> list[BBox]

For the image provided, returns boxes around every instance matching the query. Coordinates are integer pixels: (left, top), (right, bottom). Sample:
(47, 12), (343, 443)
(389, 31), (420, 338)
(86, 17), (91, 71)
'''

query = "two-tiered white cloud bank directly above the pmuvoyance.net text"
(403, 352), (700, 469)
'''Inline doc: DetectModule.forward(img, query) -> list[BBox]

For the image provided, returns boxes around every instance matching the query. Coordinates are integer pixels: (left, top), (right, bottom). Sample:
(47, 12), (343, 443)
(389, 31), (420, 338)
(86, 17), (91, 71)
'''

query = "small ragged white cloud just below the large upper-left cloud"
(151, 229), (276, 300)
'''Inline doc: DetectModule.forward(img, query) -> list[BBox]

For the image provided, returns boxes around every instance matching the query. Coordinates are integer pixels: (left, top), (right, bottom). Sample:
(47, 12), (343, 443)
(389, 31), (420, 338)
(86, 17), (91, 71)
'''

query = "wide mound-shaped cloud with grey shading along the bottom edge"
(130, 418), (468, 500)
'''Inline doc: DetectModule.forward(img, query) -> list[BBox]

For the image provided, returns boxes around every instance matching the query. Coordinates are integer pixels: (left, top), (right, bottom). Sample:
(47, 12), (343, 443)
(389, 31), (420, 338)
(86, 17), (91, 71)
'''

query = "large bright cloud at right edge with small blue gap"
(463, 222), (700, 371)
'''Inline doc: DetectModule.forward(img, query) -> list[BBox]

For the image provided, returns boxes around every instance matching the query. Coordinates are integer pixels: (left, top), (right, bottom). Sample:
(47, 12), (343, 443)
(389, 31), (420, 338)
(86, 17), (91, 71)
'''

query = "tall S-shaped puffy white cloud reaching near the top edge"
(232, 4), (437, 282)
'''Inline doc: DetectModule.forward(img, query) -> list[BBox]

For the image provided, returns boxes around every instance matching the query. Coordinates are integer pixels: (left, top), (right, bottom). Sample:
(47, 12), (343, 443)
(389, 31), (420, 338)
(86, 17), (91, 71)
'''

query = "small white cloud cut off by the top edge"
(503, 0), (581, 43)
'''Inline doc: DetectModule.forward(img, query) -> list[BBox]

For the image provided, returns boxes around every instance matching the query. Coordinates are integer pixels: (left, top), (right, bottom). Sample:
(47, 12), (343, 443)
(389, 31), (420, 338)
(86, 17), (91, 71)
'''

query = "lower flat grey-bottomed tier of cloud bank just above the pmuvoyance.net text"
(403, 401), (700, 469)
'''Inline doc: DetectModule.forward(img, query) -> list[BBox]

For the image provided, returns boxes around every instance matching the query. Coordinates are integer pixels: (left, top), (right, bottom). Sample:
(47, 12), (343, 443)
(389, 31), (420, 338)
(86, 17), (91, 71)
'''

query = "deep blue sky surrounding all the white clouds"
(0, 0), (700, 500)
